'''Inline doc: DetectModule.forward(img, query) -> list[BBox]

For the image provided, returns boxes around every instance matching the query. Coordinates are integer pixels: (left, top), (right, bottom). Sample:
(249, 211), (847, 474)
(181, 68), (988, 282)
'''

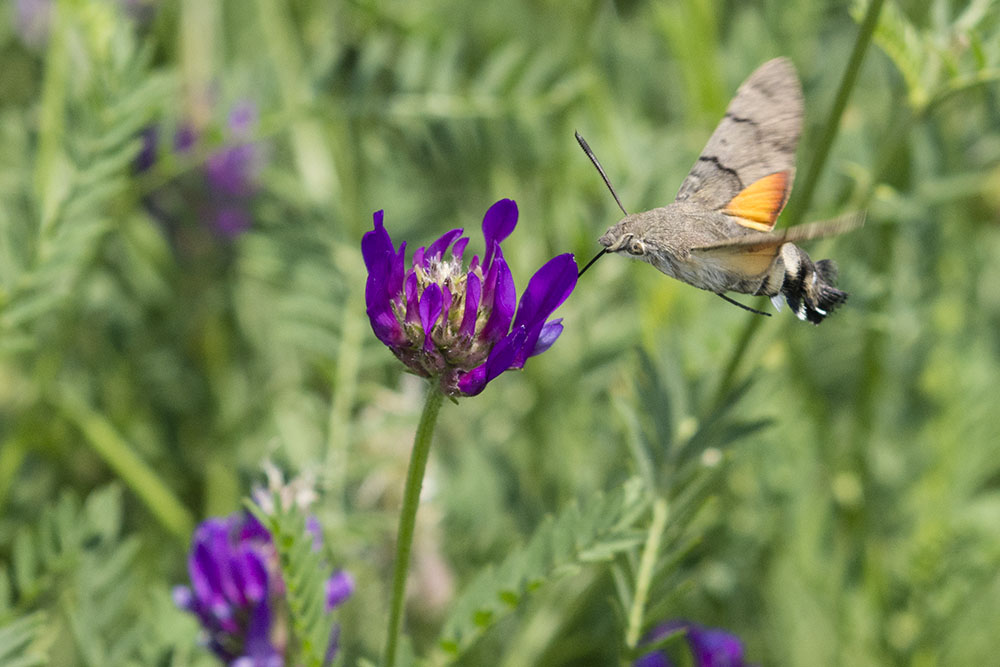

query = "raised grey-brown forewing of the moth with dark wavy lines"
(677, 58), (803, 217)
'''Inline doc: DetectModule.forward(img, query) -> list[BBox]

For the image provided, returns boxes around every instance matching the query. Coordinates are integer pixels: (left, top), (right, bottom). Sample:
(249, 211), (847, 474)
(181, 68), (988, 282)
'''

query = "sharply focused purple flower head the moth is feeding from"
(361, 199), (577, 396)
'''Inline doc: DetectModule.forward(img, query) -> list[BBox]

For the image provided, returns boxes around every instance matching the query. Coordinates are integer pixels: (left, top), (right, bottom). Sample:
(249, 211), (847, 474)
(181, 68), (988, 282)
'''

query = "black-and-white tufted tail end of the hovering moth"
(781, 248), (847, 324)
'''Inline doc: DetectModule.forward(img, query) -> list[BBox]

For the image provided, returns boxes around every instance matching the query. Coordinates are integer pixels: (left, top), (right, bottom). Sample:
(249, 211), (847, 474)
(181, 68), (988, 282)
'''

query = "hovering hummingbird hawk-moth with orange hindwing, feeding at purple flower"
(576, 58), (864, 324)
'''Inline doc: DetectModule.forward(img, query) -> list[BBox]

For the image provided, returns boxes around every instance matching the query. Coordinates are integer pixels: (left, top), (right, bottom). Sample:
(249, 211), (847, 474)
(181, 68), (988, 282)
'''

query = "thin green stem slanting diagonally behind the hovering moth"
(713, 0), (884, 409)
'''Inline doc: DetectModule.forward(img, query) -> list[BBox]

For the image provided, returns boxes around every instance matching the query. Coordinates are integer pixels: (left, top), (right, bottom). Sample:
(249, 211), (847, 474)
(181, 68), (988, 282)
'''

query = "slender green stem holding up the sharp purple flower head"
(382, 383), (444, 667)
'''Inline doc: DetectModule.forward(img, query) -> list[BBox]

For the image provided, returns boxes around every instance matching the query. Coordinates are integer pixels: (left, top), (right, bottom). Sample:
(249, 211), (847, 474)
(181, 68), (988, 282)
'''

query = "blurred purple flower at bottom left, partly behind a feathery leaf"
(173, 512), (354, 667)
